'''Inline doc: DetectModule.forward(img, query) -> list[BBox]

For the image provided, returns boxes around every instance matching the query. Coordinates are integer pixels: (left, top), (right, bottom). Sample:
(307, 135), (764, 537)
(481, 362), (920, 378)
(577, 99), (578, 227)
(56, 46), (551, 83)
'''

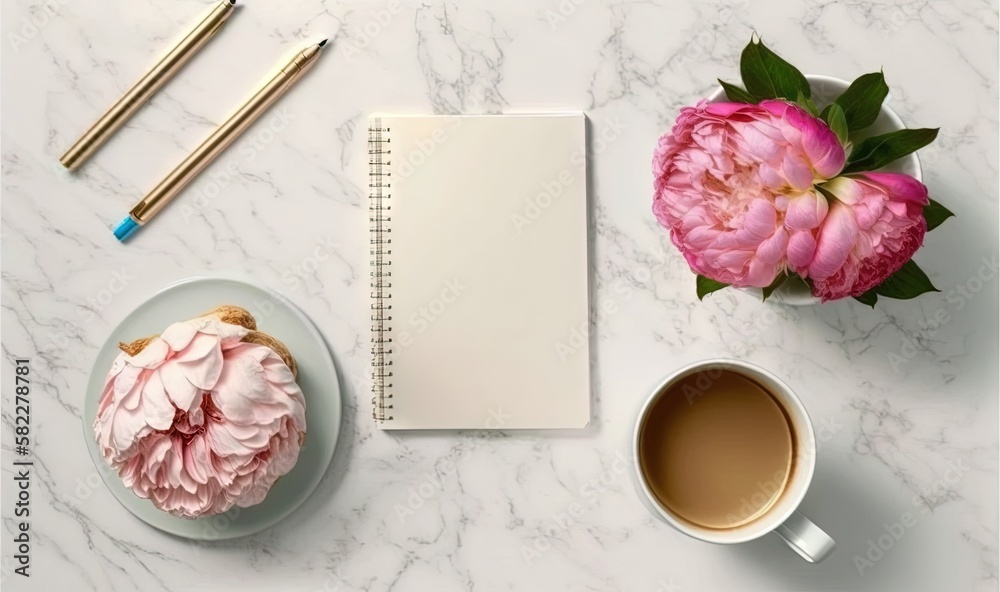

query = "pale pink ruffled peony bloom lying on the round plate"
(94, 316), (306, 518)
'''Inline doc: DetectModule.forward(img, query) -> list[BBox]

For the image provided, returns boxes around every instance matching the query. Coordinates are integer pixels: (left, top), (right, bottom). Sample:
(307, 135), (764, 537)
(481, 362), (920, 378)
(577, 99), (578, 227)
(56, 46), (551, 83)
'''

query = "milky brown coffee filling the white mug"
(639, 369), (795, 528)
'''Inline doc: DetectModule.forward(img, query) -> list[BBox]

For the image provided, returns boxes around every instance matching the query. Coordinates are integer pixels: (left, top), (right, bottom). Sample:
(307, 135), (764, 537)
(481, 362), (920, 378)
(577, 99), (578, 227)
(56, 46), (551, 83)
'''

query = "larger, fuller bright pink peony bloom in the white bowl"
(653, 100), (845, 287)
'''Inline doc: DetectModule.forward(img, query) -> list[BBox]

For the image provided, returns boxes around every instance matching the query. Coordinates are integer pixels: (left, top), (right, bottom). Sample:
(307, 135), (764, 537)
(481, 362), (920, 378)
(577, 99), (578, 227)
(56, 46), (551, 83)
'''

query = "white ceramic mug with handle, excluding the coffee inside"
(632, 359), (836, 563)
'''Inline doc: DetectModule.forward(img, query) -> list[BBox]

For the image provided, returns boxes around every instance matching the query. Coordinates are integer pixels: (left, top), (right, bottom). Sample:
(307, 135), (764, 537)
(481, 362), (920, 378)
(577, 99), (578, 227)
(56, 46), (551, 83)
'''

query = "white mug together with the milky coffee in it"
(633, 360), (835, 562)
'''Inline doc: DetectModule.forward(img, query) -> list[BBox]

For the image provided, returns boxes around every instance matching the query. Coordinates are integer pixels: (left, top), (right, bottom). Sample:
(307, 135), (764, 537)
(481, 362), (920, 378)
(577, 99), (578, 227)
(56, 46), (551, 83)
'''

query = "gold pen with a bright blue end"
(114, 39), (326, 241)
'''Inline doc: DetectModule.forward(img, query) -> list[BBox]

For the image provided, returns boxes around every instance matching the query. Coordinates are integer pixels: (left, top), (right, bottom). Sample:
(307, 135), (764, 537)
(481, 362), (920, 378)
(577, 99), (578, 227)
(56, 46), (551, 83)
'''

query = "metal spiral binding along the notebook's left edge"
(368, 118), (392, 422)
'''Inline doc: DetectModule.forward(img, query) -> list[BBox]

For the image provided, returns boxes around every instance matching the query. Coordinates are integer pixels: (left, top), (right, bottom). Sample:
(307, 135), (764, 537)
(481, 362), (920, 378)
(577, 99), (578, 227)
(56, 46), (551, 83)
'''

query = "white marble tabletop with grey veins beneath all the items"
(0, 0), (998, 592)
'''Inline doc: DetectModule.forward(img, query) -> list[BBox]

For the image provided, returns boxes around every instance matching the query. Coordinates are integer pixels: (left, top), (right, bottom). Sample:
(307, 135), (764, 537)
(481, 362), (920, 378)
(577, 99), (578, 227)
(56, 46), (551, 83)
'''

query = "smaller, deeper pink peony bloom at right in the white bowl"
(788, 173), (929, 302)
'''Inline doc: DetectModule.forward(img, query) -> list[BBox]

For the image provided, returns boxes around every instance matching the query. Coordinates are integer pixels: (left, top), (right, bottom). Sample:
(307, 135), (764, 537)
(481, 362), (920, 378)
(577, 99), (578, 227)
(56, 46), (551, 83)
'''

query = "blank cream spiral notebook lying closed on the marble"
(368, 113), (590, 429)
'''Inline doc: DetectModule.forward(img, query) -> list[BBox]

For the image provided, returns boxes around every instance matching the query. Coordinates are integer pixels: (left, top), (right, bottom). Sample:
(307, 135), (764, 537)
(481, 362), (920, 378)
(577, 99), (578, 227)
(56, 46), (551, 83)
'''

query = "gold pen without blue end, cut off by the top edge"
(59, 0), (236, 171)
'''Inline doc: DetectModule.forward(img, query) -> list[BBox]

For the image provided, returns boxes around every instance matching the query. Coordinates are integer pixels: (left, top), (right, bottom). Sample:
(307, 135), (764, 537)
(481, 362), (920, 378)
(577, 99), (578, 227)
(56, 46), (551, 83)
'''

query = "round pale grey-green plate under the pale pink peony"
(83, 278), (341, 540)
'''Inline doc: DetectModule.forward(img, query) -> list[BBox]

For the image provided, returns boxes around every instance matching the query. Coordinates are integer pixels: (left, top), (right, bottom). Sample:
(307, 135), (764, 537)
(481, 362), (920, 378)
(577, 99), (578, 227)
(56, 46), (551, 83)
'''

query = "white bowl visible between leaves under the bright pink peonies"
(708, 74), (923, 306)
